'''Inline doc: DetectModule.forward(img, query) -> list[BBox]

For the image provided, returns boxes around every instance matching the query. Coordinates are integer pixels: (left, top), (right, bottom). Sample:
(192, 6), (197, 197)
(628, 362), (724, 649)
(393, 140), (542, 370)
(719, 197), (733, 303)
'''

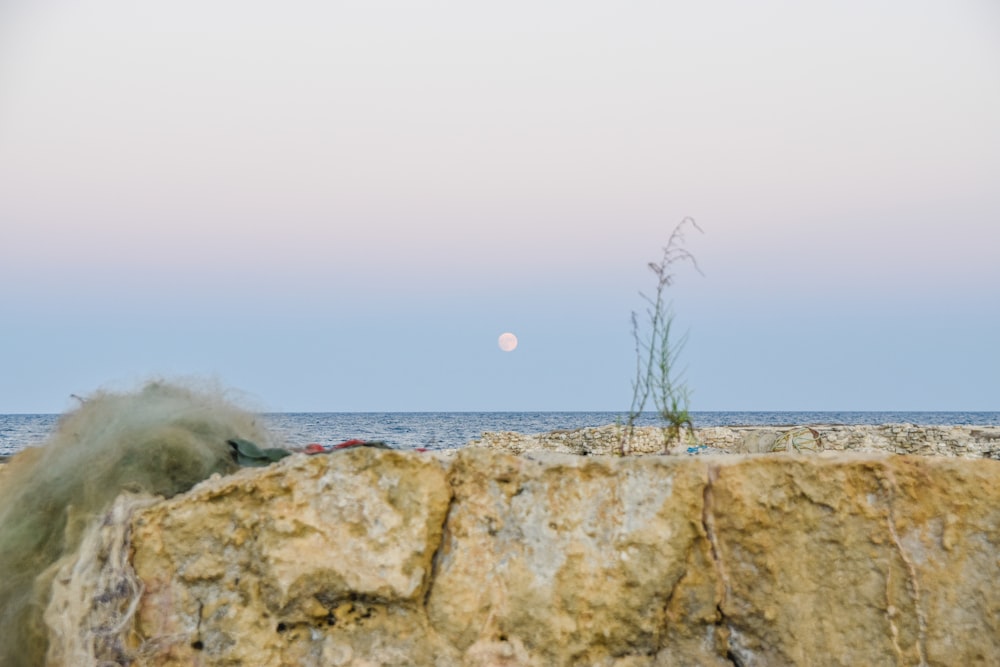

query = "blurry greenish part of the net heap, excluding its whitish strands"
(0, 382), (269, 667)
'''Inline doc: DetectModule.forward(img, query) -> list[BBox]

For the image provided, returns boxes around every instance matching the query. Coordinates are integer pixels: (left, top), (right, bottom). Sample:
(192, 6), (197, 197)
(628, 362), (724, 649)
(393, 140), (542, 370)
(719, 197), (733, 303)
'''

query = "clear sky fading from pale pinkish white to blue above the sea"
(0, 0), (1000, 413)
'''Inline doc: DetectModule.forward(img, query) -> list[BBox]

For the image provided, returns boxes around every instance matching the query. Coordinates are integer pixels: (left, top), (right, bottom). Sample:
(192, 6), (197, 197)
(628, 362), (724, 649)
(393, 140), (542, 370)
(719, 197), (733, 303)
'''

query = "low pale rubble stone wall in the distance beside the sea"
(471, 424), (1000, 459)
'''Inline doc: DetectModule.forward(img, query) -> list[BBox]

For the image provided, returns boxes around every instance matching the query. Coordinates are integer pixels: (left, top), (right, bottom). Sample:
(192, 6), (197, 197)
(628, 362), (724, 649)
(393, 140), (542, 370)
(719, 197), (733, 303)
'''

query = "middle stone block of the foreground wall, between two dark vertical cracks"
(428, 449), (718, 665)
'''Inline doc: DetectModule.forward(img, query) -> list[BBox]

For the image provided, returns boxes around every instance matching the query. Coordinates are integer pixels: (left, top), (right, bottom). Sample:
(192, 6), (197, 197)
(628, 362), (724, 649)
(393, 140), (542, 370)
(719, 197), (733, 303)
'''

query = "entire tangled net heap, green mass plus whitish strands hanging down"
(0, 383), (278, 667)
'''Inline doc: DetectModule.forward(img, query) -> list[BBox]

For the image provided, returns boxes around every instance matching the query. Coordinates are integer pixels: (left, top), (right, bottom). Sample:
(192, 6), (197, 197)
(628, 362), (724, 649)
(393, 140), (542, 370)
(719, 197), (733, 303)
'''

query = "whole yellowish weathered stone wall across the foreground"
(47, 448), (1000, 667)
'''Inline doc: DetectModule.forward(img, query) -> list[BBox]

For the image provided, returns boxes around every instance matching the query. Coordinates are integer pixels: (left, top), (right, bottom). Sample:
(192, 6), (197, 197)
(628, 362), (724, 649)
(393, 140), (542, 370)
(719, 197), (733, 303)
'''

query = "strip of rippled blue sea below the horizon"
(0, 412), (1000, 457)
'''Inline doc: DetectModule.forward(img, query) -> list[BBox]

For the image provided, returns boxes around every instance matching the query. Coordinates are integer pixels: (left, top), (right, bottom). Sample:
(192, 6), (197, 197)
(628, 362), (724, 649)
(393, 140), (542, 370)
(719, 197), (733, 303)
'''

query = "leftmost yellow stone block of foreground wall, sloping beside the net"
(133, 448), (451, 665)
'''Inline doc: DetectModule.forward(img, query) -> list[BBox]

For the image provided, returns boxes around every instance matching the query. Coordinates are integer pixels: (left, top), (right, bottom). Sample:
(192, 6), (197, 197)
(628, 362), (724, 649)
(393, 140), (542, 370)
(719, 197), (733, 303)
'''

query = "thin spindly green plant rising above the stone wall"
(618, 218), (702, 454)
